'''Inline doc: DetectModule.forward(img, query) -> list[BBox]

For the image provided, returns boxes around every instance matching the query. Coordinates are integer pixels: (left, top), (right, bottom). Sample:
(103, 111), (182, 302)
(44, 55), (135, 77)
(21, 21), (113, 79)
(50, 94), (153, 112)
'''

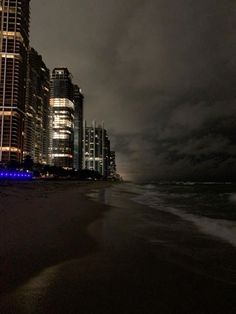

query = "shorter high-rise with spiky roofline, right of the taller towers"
(83, 121), (110, 177)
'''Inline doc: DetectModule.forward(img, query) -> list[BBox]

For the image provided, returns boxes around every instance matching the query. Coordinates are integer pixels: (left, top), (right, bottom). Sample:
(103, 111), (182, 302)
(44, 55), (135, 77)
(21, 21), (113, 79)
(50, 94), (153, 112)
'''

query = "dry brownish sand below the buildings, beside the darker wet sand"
(0, 181), (111, 294)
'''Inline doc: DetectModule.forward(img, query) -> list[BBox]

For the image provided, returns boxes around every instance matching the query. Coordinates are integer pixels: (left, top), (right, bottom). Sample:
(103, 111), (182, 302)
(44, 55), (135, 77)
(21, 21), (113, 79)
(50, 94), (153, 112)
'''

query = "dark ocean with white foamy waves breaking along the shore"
(133, 182), (236, 247)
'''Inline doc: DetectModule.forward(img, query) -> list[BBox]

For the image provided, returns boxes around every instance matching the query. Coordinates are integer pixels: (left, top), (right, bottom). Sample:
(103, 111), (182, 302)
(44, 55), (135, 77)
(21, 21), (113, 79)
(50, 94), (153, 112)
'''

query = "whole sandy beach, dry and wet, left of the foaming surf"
(0, 184), (236, 314)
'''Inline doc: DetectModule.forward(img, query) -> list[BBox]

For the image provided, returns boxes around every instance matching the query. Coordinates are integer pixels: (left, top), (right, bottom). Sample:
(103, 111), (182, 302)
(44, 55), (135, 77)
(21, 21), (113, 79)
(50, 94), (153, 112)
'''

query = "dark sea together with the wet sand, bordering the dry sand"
(1, 184), (236, 314)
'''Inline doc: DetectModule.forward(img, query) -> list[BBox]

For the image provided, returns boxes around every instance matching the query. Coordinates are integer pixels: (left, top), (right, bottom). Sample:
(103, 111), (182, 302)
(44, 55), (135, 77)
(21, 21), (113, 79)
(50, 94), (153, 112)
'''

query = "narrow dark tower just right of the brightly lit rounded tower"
(73, 85), (84, 170)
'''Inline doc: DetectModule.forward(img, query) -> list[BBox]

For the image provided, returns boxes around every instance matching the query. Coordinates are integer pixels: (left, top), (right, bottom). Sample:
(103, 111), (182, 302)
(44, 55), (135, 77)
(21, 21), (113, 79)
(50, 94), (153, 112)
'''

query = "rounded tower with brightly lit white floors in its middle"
(49, 67), (75, 169)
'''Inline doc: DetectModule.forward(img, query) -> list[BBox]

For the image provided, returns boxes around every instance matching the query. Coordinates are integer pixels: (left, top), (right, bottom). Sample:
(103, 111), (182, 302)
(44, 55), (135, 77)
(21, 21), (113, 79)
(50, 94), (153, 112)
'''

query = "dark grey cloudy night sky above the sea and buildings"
(30, 0), (236, 181)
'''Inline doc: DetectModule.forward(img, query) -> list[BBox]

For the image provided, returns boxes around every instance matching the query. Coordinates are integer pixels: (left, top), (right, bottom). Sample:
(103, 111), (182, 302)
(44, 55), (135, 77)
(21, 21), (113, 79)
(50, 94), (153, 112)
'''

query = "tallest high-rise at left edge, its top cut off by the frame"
(0, 0), (30, 162)
